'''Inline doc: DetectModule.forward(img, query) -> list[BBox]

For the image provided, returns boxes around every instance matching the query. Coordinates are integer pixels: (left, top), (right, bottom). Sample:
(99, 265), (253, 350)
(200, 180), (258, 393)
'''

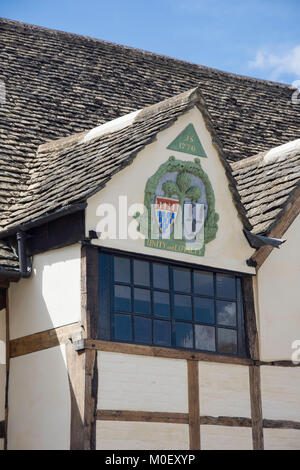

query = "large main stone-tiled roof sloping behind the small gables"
(0, 19), (300, 272)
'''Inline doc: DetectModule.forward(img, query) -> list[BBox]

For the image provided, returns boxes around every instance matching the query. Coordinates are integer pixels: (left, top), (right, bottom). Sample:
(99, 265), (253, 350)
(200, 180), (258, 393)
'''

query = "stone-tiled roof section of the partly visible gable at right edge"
(231, 139), (300, 235)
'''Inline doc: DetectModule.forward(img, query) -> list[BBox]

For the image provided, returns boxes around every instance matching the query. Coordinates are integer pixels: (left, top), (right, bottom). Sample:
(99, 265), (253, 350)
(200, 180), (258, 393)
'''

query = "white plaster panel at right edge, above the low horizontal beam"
(261, 366), (300, 421)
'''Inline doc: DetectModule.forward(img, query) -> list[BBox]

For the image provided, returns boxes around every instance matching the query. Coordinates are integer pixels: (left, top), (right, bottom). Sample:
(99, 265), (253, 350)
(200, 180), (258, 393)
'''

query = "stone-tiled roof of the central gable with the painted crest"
(4, 89), (240, 231)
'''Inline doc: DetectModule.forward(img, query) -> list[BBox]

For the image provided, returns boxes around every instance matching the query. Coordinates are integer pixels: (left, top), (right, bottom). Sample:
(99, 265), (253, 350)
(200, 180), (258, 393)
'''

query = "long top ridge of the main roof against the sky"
(0, 17), (294, 89)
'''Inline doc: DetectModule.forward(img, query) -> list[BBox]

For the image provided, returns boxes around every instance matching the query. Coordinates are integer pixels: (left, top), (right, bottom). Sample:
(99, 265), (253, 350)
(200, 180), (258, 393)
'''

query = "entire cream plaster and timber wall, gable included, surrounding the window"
(4, 109), (300, 449)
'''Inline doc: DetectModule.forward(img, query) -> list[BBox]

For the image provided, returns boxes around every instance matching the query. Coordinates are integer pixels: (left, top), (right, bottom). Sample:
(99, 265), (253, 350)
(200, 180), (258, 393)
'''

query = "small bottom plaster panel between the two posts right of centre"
(200, 425), (253, 450)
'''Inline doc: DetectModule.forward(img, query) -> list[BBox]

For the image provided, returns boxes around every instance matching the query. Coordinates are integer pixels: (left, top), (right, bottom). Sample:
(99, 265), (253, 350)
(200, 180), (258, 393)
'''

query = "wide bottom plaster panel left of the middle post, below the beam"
(96, 421), (189, 450)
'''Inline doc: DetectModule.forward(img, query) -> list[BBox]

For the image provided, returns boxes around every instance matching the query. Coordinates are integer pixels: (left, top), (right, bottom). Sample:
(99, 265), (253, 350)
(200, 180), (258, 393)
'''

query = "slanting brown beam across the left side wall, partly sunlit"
(9, 322), (81, 358)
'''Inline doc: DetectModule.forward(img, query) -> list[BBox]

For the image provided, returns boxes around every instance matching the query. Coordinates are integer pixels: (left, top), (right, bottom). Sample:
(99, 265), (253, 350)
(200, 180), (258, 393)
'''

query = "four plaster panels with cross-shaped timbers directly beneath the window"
(96, 351), (252, 449)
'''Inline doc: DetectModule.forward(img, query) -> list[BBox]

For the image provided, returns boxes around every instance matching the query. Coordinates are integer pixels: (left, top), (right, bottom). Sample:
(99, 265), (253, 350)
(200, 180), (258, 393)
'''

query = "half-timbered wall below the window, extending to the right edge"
(92, 341), (300, 450)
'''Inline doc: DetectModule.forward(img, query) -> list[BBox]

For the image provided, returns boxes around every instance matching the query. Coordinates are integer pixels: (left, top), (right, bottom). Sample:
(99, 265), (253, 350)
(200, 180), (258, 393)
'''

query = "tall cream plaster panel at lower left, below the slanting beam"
(8, 346), (70, 450)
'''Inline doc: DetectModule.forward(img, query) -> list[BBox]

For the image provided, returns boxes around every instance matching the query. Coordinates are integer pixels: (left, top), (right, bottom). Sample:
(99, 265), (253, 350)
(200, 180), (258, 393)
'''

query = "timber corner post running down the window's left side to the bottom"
(66, 242), (98, 450)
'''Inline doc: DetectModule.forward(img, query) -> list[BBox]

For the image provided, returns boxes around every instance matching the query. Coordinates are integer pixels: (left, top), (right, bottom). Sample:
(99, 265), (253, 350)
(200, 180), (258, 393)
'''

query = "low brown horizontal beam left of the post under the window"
(97, 410), (189, 424)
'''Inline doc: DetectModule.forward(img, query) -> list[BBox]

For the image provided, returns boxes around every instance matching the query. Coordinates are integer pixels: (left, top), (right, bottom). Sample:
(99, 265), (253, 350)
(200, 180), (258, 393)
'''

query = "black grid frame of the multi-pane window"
(98, 248), (249, 358)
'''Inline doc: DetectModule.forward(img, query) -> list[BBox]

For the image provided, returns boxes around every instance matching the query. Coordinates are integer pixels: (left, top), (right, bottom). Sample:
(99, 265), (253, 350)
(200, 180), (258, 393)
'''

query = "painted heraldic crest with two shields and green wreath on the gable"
(135, 156), (219, 256)
